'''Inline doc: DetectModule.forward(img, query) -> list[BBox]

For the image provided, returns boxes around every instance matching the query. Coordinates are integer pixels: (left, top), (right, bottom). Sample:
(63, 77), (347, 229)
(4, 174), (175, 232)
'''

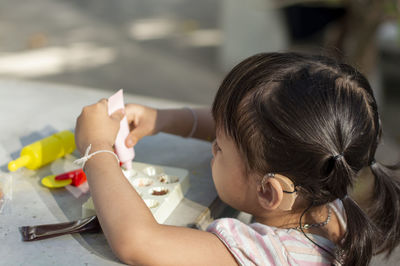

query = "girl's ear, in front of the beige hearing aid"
(257, 178), (283, 211)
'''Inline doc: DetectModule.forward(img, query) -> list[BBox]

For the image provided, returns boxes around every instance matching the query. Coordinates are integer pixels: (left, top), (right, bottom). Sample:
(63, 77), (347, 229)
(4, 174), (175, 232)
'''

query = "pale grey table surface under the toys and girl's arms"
(0, 80), (217, 265)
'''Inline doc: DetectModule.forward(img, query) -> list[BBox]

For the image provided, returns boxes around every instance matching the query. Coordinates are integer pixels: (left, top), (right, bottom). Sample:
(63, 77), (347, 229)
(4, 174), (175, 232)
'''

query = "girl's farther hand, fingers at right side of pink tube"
(125, 104), (160, 147)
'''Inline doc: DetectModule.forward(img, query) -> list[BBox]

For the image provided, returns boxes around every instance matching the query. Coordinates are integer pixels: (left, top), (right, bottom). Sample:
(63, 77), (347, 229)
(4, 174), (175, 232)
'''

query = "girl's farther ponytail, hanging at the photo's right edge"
(367, 162), (400, 257)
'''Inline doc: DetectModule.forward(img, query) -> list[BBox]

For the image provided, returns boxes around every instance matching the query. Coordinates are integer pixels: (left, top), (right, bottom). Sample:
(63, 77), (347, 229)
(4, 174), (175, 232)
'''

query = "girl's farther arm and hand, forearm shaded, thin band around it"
(125, 104), (215, 147)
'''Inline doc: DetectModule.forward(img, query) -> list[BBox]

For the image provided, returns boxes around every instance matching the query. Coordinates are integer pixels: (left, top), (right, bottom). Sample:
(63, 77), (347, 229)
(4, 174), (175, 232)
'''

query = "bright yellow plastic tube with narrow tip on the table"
(8, 130), (75, 172)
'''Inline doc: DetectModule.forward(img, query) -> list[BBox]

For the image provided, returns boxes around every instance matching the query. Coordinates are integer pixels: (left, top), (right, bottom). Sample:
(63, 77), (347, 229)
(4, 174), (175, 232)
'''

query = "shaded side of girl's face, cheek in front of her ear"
(211, 131), (258, 213)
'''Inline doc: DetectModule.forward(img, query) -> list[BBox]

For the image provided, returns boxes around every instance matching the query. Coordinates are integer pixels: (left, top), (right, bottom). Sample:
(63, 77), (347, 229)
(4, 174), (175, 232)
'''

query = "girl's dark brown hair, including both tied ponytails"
(212, 53), (400, 265)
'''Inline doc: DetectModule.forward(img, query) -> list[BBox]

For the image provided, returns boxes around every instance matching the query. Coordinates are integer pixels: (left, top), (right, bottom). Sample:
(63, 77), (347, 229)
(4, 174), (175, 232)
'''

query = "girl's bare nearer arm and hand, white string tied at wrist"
(75, 100), (236, 265)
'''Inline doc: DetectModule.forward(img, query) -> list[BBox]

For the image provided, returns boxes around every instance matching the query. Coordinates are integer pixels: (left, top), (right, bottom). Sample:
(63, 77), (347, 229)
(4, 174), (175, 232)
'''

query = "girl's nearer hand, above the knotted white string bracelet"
(75, 99), (125, 154)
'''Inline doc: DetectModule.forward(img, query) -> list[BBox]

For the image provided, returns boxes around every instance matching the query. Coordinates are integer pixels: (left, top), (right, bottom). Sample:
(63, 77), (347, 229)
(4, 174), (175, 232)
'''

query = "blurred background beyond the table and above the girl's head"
(0, 0), (400, 145)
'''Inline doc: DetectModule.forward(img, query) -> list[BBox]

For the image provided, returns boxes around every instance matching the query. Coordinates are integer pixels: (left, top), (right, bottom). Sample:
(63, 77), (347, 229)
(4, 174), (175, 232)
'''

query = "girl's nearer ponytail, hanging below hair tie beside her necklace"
(337, 196), (376, 266)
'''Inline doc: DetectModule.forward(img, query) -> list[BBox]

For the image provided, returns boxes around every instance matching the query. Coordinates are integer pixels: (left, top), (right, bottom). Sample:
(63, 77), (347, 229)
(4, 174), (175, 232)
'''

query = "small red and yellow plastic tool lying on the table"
(42, 169), (86, 188)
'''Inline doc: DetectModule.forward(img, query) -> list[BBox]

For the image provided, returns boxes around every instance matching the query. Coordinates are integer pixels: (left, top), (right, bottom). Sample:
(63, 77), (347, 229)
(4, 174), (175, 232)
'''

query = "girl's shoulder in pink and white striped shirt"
(207, 218), (336, 265)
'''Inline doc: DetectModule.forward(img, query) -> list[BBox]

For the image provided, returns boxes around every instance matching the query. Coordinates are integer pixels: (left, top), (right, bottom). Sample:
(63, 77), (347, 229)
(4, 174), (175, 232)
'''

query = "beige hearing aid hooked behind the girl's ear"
(261, 173), (297, 211)
